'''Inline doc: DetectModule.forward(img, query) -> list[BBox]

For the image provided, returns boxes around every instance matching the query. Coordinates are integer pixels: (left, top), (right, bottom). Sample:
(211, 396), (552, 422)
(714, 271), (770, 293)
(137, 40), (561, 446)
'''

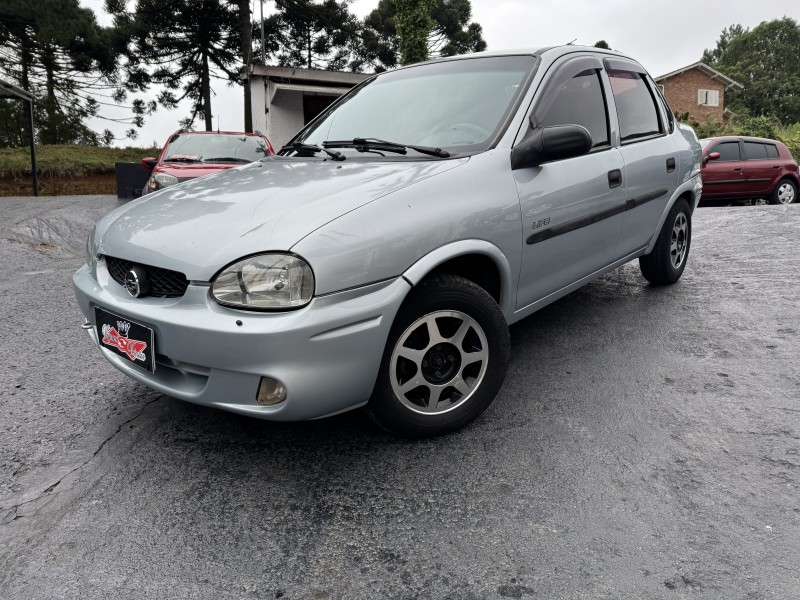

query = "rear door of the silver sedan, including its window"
(603, 58), (679, 258)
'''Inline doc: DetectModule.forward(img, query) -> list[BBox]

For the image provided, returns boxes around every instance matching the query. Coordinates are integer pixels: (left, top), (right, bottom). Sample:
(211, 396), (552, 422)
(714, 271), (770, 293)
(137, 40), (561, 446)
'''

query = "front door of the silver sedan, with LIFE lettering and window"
(514, 57), (625, 310)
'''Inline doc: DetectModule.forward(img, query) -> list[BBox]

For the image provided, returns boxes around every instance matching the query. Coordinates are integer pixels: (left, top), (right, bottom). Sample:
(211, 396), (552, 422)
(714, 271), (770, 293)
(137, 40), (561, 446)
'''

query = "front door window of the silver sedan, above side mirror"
(540, 69), (609, 148)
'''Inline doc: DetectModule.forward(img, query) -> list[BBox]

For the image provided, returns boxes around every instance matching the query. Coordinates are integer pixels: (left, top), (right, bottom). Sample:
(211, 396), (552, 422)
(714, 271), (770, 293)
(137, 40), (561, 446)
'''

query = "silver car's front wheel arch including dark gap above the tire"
(403, 240), (514, 317)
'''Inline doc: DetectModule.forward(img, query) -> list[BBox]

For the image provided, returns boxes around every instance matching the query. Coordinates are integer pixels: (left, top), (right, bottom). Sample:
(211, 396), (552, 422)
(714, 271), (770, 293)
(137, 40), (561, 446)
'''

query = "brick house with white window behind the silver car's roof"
(655, 62), (744, 123)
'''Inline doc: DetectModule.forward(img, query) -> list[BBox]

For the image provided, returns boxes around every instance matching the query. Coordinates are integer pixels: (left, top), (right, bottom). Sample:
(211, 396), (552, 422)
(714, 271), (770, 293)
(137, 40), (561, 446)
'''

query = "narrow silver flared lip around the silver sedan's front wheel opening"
(402, 239), (516, 319)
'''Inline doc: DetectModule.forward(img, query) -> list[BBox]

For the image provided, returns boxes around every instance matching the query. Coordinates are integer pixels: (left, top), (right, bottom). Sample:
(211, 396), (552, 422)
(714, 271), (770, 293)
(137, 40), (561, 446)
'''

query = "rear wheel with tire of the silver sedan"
(639, 198), (692, 285)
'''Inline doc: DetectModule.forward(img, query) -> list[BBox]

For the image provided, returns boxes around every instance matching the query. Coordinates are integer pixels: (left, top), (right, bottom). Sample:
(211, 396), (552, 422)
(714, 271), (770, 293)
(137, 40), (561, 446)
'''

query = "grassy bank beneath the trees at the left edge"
(0, 145), (161, 178)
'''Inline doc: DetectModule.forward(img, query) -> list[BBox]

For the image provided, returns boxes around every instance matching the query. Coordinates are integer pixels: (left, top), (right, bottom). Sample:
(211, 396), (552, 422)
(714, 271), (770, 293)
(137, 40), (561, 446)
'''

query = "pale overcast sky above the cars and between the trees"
(80, 0), (800, 146)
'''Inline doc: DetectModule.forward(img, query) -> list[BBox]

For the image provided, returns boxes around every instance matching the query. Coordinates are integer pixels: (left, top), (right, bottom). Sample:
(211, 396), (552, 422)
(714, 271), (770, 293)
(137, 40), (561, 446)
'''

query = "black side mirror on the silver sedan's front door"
(511, 125), (592, 171)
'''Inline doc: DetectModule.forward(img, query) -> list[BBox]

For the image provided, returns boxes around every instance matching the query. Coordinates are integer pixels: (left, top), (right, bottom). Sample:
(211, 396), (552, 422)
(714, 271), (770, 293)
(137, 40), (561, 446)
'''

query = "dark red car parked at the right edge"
(700, 136), (800, 204)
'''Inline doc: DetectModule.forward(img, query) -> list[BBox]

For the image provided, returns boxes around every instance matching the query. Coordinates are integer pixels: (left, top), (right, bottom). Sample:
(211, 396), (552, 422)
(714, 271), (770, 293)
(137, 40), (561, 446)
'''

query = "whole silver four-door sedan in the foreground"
(74, 46), (702, 436)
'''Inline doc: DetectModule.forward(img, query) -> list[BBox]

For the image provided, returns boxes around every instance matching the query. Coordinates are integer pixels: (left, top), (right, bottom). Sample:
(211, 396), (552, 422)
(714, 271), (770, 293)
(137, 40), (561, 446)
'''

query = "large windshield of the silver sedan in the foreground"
(294, 56), (534, 153)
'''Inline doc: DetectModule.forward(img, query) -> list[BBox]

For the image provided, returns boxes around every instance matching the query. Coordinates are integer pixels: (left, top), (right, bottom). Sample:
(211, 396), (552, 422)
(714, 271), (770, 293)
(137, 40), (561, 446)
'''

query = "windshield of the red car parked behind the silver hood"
(162, 133), (269, 163)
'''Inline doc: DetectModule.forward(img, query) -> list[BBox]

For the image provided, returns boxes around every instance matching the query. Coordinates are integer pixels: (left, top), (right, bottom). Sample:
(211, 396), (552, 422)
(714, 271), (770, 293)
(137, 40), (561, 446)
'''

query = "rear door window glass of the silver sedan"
(608, 70), (663, 143)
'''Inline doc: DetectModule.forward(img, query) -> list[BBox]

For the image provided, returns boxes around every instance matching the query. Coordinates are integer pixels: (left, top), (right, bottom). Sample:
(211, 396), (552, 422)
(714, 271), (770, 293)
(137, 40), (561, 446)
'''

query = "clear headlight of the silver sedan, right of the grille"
(211, 254), (314, 310)
